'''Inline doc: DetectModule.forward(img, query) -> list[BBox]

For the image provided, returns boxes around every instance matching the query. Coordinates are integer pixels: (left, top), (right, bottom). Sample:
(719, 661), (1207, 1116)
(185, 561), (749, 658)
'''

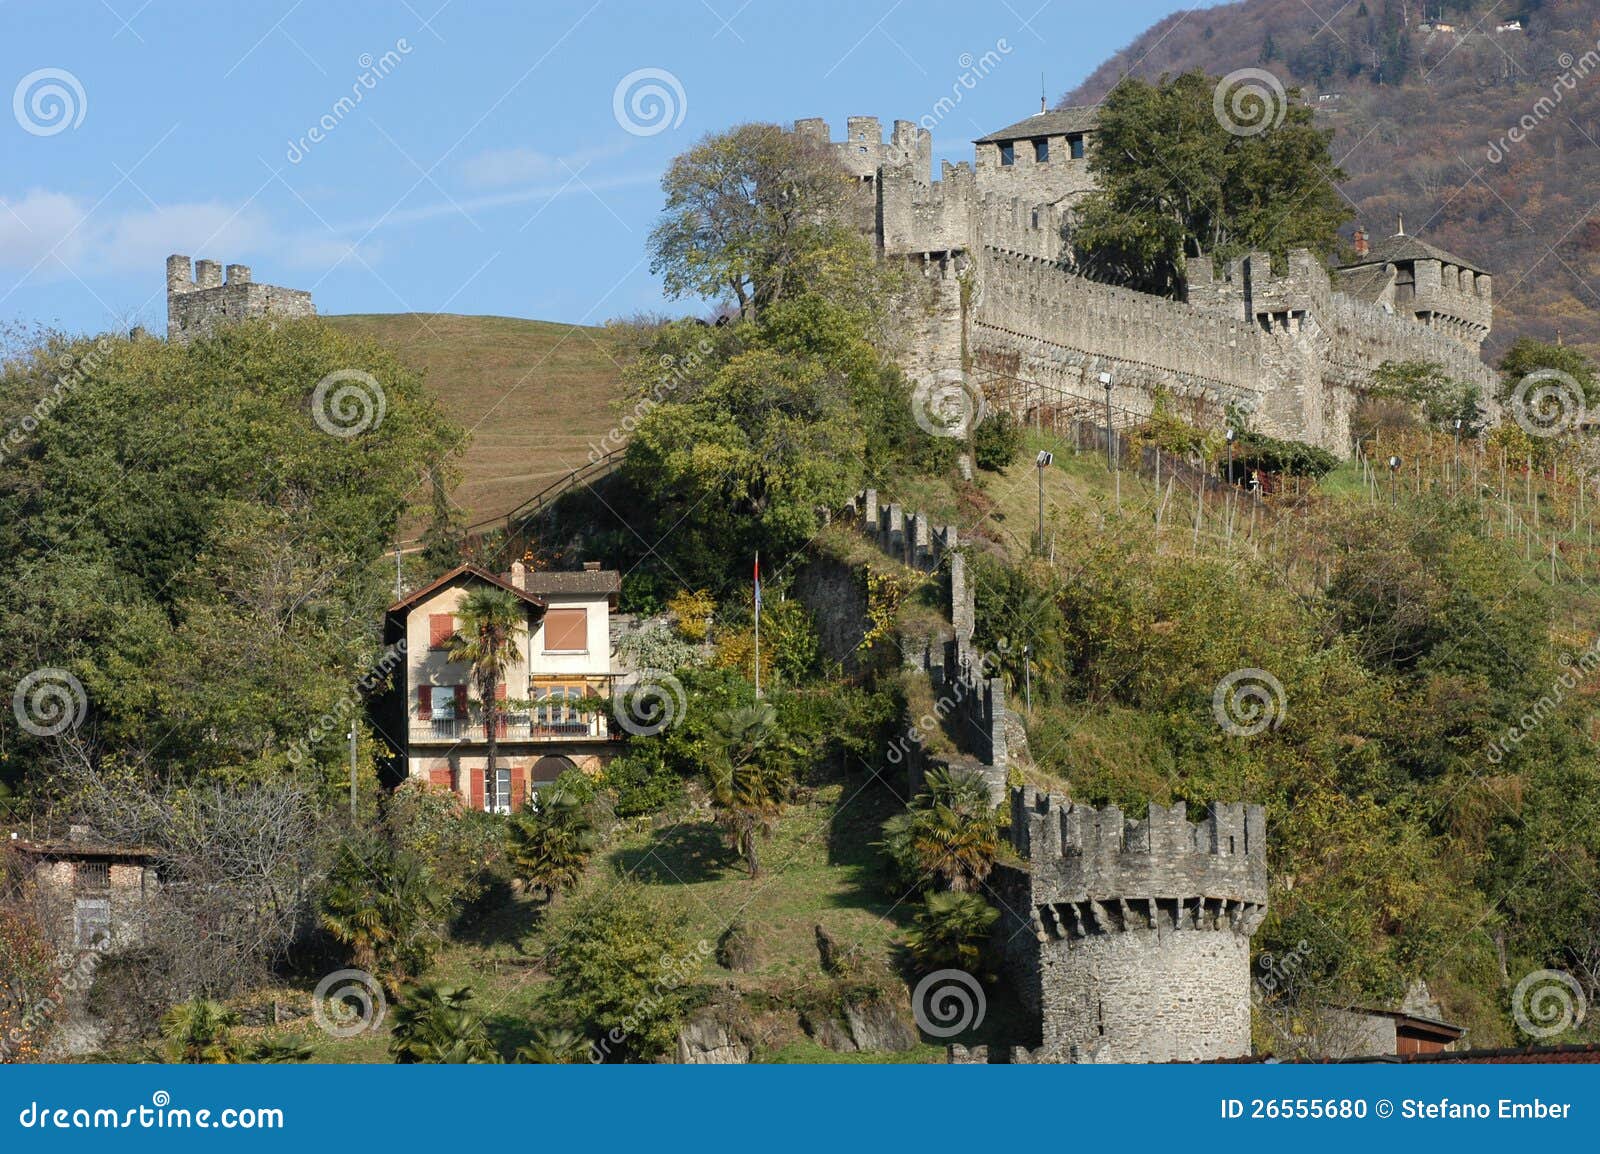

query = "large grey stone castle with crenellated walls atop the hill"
(795, 109), (1494, 456)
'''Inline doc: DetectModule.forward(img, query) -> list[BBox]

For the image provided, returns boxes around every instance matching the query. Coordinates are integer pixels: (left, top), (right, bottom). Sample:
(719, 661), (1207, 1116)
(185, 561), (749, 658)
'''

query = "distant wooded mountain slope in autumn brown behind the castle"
(1064, 0), (1600, 360)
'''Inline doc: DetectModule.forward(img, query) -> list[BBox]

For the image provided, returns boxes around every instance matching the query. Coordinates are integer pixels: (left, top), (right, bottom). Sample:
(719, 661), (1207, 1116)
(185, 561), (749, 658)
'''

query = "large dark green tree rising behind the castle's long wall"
(1072, 72), (1350, 295)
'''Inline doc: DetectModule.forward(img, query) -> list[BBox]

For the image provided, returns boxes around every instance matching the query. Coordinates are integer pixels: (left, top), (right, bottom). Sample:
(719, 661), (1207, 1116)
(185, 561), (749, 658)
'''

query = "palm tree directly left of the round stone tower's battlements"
(882, 767), (1000, 893)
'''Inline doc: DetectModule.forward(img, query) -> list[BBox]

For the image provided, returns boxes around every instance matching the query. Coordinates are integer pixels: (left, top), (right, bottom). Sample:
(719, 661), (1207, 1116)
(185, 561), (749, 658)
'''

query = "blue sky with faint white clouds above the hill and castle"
(0, 0), (1222, 331)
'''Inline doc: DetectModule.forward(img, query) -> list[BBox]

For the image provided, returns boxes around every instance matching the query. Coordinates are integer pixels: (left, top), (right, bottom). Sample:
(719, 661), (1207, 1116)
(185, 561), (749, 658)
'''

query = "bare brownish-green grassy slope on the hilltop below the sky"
(328, 312), (621, 522)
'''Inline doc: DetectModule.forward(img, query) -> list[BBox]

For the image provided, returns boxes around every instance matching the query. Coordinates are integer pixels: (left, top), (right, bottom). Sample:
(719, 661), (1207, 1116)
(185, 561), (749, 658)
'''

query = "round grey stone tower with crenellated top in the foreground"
(997, 789), (1267, 1061)
